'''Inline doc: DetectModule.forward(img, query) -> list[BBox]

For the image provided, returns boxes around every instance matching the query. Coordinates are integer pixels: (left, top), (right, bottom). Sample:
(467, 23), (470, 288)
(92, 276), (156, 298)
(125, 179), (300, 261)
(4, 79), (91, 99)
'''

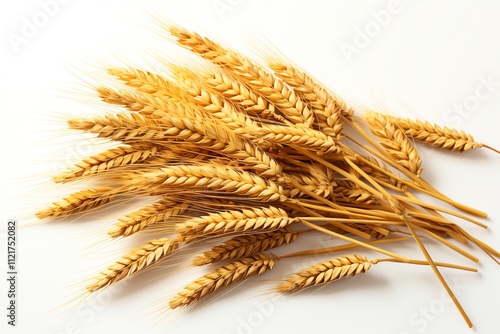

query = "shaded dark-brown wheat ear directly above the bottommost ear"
(193, 227), (302, 266)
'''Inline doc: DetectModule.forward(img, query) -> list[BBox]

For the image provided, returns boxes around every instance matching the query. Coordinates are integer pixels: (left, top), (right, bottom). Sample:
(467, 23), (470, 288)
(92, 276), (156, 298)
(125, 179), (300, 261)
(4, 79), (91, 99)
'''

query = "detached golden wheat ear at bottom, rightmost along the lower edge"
(276, 255), (372, 293)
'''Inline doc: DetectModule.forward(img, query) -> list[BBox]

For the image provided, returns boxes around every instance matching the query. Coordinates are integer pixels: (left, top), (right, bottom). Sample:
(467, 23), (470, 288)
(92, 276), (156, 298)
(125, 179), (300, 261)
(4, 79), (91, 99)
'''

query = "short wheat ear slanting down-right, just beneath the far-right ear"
(366, 112), (422, 176)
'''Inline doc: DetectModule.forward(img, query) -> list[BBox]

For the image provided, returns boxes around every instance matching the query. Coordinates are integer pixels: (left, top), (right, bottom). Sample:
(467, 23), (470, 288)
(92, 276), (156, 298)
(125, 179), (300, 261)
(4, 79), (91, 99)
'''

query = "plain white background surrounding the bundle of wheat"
(0, 0), (500, 334)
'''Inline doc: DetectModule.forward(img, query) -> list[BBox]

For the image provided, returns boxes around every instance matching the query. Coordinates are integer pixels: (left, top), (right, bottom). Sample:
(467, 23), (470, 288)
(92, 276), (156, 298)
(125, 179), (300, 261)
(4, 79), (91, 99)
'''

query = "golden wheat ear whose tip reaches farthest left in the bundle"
(36, 187), (117, 219)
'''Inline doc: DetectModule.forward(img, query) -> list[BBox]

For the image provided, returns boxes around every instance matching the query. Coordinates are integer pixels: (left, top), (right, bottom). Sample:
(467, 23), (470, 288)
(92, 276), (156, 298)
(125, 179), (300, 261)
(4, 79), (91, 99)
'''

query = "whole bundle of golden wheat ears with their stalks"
(37, 25), (500, 326)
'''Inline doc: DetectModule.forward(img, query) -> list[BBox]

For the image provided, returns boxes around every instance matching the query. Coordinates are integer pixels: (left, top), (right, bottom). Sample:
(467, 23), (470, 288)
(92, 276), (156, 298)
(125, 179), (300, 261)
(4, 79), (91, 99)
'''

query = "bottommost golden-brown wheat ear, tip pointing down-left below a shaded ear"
(169, 253), (276, 309)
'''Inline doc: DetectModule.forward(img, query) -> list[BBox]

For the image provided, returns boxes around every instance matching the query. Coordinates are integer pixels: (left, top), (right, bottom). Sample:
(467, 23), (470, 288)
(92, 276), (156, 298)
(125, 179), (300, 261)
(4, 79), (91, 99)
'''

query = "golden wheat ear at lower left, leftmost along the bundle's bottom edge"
(86, 238), (178, 292)
